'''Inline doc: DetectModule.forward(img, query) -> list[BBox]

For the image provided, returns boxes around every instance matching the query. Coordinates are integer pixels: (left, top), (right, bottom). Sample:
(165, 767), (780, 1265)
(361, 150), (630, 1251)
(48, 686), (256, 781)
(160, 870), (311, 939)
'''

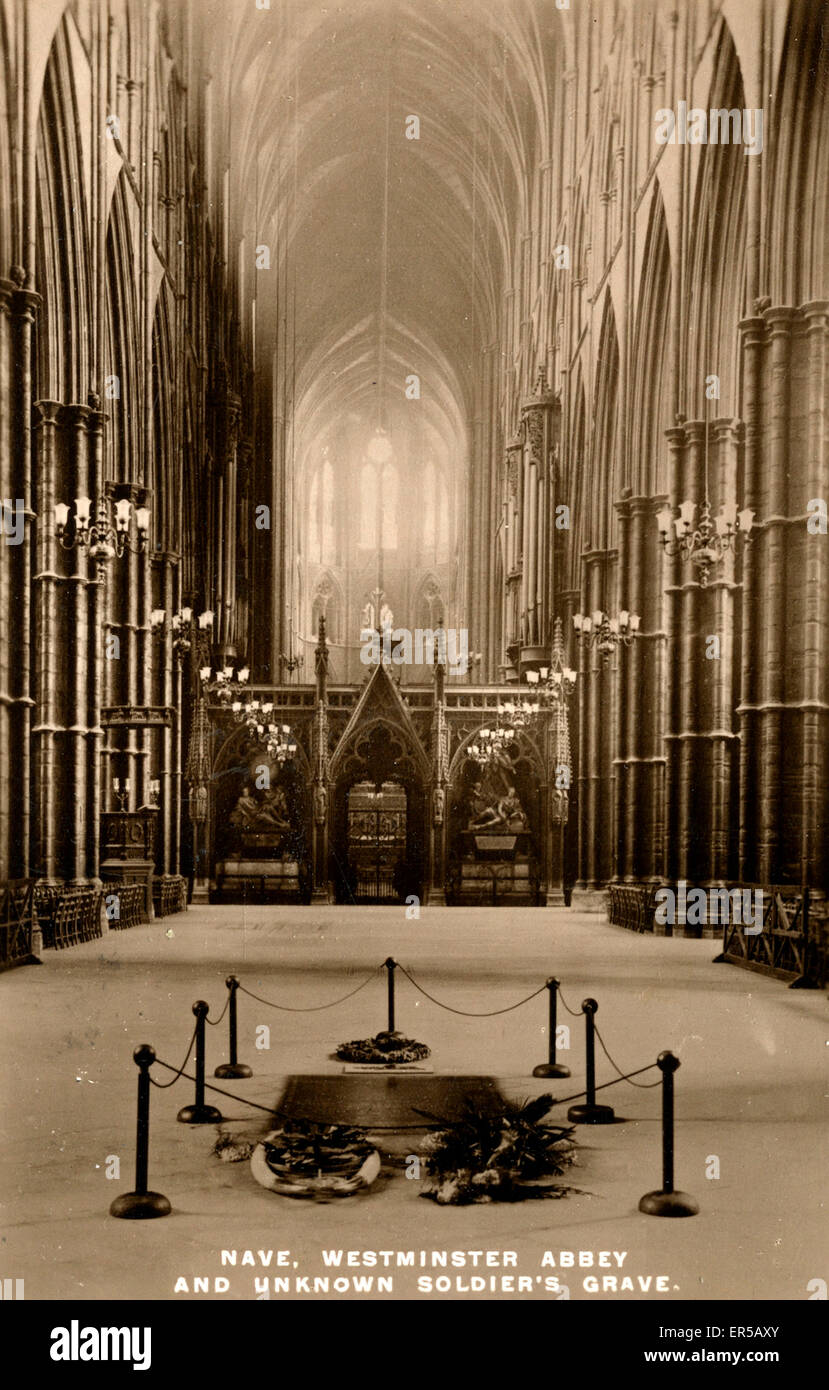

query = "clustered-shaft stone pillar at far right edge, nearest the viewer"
(739, 300), (829, 891)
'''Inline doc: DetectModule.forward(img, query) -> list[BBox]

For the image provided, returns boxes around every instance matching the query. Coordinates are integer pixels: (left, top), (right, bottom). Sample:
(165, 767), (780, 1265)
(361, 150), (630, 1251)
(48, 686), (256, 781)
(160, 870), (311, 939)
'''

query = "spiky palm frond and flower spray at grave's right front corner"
(420, 1095), (576, 1207)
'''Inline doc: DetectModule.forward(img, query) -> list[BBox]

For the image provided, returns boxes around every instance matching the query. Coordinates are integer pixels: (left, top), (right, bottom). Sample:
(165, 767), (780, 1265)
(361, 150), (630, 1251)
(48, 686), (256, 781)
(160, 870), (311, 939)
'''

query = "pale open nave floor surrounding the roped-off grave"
(0, 906), (829, 1300)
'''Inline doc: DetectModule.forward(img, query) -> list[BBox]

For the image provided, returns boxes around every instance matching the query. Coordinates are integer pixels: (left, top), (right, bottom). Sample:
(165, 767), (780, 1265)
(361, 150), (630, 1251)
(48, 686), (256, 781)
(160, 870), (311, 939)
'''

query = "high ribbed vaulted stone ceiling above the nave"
(203, 0), (561, 472)
